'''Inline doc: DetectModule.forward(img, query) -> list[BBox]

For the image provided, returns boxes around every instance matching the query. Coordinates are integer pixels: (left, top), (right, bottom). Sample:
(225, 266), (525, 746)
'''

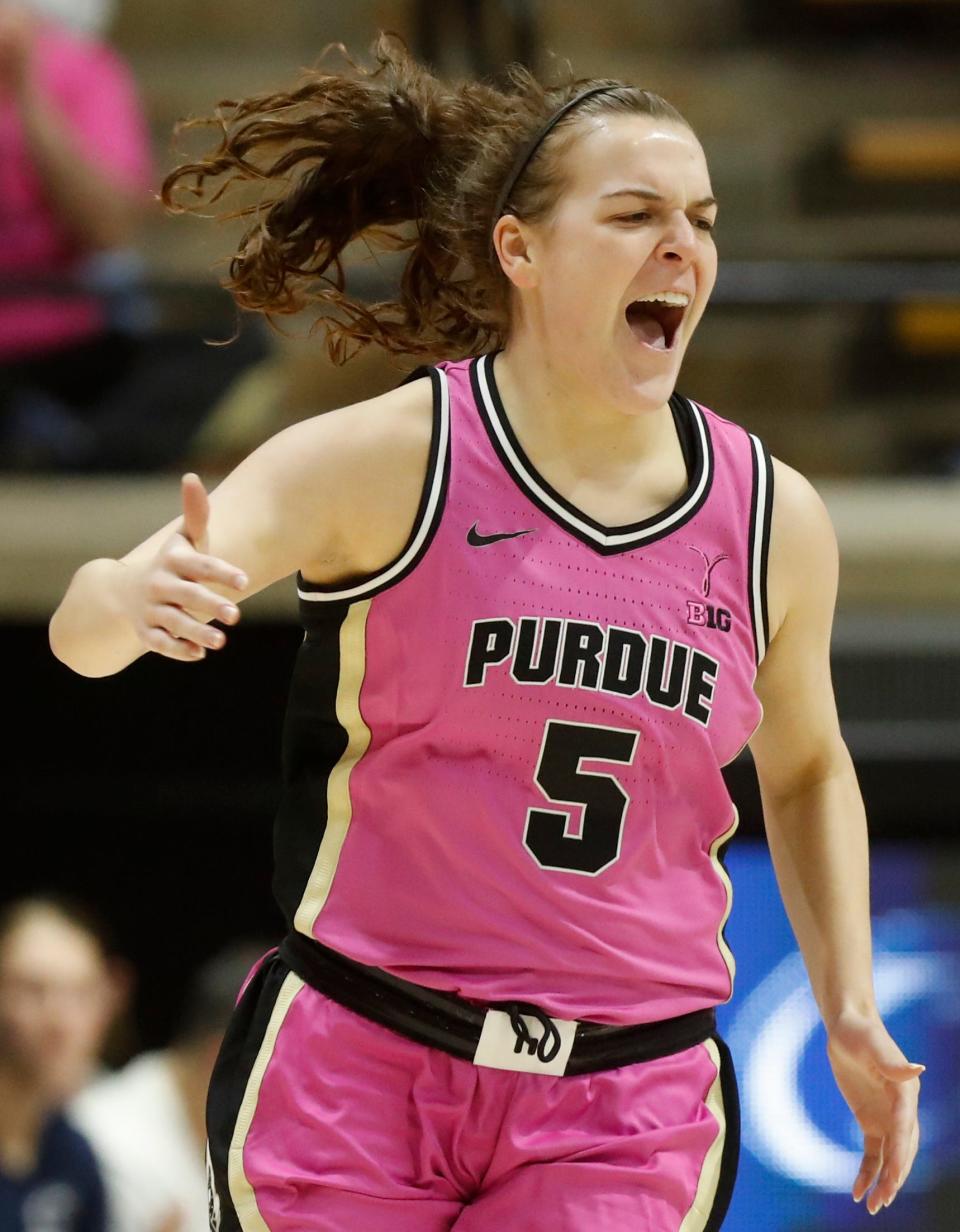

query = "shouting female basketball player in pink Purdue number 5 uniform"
(51, 41), (922, 1232)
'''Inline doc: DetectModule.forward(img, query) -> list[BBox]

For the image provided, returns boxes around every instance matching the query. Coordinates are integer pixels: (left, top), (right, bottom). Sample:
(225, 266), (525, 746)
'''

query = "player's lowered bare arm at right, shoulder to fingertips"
(751, 461), (922, 1215)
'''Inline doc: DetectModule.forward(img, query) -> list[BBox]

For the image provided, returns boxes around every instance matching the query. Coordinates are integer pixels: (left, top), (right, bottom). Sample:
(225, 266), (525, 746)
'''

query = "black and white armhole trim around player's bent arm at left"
(297, 368), (450, 605)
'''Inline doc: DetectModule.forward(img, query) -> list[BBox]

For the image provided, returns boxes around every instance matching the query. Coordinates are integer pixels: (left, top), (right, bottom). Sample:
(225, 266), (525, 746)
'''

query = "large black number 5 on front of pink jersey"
(524, 718), (640, 876)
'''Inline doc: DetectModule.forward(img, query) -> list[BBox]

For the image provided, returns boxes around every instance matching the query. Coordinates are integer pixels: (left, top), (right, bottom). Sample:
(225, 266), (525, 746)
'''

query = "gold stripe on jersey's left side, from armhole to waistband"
(293, 599), (372, 936)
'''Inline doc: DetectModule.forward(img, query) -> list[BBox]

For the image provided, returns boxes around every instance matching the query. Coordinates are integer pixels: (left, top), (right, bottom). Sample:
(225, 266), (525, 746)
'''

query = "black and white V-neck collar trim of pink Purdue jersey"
(470, 355), (714, 556)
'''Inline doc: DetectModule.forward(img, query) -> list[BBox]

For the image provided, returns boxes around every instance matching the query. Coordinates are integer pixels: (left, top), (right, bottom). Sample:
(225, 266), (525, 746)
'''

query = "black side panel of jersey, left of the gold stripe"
(274, 602), (350, 929)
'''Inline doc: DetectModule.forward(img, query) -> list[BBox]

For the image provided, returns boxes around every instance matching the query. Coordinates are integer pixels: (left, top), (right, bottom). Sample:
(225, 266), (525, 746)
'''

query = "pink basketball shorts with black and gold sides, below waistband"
(207, 954), (738, 1232)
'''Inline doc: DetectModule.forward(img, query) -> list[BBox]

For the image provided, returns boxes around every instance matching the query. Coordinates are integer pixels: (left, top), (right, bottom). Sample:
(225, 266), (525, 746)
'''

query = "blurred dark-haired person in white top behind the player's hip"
(70, 945), (265, 1232)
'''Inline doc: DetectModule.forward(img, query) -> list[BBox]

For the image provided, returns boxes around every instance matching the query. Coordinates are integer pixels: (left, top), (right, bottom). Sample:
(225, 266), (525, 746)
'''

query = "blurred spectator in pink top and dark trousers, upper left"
(0, 0), (267, 471)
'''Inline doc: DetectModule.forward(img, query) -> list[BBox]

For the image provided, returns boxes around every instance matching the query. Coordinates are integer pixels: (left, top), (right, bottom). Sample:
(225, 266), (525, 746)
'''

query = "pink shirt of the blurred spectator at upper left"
(0, 25), (152, 362)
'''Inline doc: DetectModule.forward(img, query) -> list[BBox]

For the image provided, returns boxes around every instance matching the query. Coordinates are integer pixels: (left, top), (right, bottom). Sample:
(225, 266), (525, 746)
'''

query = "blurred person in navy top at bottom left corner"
(0, 898), (115, 1232)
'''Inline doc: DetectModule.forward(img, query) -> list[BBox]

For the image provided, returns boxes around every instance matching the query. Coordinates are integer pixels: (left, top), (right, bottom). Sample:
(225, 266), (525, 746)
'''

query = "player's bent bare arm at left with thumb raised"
(49, 379), (433, 676)
